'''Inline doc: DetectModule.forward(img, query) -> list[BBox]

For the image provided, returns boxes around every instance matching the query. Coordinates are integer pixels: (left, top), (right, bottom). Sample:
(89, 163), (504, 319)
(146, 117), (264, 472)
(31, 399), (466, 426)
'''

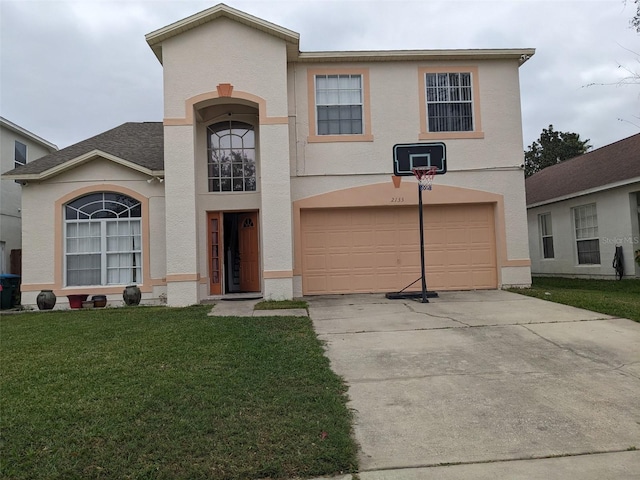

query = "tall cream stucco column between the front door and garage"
(260, 124), (293, 300)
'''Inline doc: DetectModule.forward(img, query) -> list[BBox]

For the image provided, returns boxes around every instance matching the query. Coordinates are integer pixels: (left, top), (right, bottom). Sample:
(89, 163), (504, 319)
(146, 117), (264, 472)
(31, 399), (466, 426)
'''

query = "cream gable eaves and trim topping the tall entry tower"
(145, 3), (300, 63)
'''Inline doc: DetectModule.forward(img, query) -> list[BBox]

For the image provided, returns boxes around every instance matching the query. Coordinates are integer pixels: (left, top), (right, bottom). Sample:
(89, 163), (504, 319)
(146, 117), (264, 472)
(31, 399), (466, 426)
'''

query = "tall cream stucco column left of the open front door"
(164, 125), (199, 307)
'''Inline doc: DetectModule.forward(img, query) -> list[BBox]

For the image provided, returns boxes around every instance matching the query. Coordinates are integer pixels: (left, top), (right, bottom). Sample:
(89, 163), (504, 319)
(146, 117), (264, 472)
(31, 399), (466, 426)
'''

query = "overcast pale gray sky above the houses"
(0, 0), (640, 149)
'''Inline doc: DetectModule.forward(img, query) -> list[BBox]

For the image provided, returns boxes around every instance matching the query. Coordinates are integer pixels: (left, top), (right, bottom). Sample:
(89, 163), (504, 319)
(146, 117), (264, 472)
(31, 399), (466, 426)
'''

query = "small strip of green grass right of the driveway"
(510, 277), (640, 322)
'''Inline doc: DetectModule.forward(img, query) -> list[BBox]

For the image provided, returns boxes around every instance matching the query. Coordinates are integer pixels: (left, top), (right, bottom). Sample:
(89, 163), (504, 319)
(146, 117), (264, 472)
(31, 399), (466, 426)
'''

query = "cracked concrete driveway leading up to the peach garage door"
(307, 291), (640, 480)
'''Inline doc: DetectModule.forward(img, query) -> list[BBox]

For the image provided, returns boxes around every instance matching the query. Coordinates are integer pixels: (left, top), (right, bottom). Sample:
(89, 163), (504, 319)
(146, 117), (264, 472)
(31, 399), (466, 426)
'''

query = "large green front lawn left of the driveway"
(0, 307), (357, 480)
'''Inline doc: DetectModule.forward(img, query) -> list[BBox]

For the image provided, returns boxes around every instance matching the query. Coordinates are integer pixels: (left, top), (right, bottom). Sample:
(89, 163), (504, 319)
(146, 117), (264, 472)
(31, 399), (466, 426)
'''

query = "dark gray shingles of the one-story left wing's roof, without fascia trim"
(5, 122), (164, 176)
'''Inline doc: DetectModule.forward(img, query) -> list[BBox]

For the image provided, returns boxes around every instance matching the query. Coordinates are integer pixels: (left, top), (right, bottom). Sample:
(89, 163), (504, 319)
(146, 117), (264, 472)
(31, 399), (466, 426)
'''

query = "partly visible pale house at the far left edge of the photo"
(0, 117), (58, 274)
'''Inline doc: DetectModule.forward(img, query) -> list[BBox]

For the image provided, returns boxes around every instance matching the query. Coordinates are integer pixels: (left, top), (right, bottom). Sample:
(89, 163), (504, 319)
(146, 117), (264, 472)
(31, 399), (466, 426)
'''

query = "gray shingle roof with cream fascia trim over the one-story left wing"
(3, 122), (164, 180)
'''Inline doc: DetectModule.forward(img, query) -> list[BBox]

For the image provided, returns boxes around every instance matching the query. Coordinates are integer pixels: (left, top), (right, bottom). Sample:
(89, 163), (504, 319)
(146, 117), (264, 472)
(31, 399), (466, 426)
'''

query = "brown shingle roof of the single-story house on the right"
(525, 133), (640, 207)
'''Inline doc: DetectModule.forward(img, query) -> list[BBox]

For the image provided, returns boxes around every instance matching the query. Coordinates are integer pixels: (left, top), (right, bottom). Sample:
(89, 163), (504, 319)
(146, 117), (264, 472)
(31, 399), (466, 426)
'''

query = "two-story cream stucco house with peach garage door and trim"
(2, 4), (534, 306)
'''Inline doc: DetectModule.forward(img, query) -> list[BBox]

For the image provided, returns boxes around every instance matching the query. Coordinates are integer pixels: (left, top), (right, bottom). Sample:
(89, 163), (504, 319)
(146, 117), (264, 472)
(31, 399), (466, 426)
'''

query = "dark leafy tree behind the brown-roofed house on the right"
(524, 125), (591, 177)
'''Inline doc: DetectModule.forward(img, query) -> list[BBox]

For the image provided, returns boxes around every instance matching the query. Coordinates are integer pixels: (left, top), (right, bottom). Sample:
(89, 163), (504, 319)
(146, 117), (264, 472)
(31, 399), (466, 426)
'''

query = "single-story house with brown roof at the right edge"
(525, 134), (640, 278)
